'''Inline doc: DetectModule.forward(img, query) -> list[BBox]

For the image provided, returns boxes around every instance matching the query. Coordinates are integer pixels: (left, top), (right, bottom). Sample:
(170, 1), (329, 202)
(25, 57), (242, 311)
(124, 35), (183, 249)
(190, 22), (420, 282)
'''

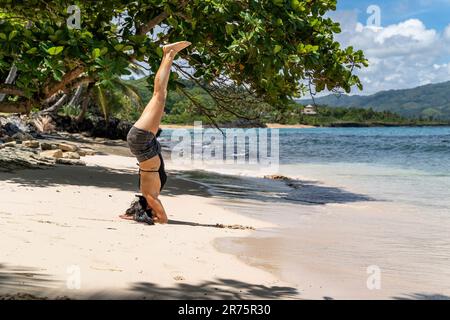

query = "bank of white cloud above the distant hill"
(334, 13), (450, 94)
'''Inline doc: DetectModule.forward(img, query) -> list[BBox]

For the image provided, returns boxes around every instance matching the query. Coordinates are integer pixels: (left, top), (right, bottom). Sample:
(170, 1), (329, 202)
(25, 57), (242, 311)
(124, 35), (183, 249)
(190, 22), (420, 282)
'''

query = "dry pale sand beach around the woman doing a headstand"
(0, 149), (298, 299)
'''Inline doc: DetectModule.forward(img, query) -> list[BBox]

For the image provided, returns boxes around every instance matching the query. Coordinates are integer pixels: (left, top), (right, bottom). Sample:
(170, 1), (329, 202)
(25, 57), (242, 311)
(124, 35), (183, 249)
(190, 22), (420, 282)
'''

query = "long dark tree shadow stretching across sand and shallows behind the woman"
(0, 166), (374, 205)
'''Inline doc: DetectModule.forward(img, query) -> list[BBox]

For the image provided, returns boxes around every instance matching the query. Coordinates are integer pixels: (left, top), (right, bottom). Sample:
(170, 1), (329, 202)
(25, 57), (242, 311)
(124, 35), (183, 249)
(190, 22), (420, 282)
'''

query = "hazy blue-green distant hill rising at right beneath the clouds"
(299, 81), (450, 120)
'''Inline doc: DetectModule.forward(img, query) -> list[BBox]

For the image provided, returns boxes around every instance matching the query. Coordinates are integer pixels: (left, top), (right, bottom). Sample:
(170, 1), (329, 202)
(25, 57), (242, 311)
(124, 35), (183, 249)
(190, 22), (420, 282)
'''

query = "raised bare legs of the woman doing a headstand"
(134, 41), (191, 135)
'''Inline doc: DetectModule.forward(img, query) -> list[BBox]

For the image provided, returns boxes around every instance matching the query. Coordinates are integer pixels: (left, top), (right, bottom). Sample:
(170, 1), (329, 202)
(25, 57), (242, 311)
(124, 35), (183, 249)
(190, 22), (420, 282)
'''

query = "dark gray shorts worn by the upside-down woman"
(127, 126), (161, 162)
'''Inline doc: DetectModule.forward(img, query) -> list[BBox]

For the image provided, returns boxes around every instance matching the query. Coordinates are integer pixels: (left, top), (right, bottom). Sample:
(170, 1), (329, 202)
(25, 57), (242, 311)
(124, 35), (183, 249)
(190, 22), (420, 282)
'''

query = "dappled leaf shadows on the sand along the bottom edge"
(0, 264), (298, 300)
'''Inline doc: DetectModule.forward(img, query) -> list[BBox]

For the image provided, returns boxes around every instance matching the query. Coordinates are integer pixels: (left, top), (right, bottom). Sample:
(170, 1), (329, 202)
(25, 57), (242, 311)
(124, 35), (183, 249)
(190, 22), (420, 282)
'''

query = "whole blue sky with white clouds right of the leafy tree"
(330, 0), (450, 94)
